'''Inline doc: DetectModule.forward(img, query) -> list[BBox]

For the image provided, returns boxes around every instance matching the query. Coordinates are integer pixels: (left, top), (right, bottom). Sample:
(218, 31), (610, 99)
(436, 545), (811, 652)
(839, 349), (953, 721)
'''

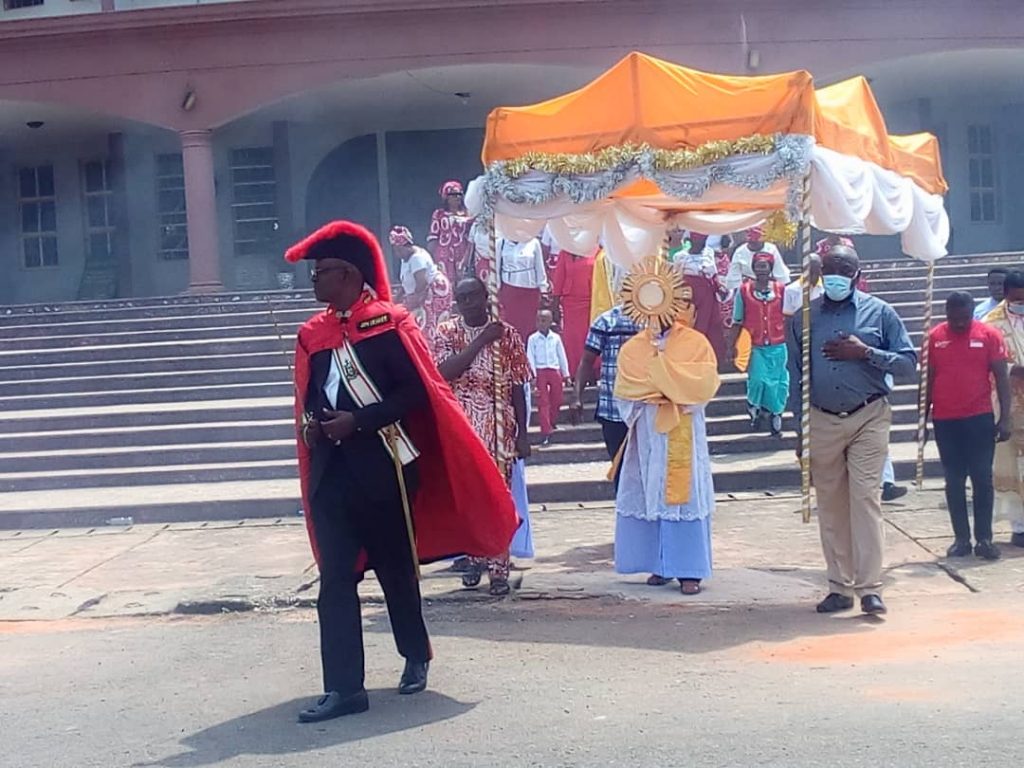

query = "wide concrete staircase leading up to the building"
(0, 254), (1024, 528)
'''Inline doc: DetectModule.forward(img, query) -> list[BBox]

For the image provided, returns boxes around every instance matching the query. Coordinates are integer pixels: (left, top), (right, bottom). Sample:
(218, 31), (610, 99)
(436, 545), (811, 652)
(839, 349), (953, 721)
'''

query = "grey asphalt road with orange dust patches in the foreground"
(8, 594), (1024, 768)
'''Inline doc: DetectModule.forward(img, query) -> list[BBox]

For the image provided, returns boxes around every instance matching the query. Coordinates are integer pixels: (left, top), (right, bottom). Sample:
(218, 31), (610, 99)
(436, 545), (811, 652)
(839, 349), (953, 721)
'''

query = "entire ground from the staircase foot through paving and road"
(0, 493), (1024, 768)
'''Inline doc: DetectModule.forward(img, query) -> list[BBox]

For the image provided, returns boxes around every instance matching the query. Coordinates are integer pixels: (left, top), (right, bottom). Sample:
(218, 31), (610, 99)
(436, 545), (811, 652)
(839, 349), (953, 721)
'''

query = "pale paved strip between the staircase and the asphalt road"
(0, 490), (1024, 621)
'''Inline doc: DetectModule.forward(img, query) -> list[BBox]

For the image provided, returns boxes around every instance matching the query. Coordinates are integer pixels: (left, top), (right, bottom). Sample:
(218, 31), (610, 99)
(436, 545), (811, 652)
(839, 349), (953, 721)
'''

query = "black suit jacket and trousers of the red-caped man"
(305, 331), (431, 696)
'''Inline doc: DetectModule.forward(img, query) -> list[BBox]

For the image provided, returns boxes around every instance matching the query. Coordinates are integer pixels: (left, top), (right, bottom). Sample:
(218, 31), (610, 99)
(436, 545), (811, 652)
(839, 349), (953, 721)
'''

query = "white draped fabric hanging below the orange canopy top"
(466, 146), (949, 267)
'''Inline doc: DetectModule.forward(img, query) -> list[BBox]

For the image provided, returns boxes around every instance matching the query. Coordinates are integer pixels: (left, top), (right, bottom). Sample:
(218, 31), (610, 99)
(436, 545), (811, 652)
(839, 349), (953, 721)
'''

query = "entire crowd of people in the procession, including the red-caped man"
(289, 186), (1024, 720)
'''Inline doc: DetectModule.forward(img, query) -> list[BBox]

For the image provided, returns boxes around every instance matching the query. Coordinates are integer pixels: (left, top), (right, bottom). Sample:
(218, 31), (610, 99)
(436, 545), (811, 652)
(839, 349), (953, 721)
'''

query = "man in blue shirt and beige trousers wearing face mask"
(788, 246), (918, 613)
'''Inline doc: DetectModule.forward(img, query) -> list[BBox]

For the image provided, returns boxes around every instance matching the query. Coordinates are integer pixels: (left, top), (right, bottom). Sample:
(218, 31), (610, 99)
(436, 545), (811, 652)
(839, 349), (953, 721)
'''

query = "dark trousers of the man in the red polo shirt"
(935, 414), (995, 542)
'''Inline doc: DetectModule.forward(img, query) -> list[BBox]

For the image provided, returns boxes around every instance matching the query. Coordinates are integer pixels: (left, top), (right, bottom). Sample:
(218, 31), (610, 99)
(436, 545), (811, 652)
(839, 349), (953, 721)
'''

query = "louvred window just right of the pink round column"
(231, 147), (278, 256)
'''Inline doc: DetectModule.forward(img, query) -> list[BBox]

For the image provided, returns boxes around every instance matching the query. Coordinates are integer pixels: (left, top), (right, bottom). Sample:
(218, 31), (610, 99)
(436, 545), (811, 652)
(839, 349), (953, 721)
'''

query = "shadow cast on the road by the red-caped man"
(144, 689), (476, 768)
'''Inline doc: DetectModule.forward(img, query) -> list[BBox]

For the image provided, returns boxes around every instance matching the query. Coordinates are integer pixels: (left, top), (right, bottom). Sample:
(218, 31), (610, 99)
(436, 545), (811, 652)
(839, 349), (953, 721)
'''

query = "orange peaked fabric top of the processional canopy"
(483, 52), (948, 194)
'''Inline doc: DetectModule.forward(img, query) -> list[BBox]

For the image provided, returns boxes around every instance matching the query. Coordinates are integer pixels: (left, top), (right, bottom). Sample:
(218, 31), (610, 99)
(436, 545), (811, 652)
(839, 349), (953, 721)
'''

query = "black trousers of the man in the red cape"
(310, 471), (431, 695)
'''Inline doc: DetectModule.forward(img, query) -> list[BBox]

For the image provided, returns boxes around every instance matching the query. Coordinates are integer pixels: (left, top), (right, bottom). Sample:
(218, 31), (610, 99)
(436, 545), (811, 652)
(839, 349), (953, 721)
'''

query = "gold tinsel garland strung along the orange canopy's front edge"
(504, 134), (775, 178)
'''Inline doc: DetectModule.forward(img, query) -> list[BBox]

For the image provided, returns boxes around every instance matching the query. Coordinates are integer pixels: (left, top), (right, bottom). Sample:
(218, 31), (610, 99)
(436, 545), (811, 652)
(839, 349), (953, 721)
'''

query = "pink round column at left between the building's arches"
(181, 130), (224, 293)
